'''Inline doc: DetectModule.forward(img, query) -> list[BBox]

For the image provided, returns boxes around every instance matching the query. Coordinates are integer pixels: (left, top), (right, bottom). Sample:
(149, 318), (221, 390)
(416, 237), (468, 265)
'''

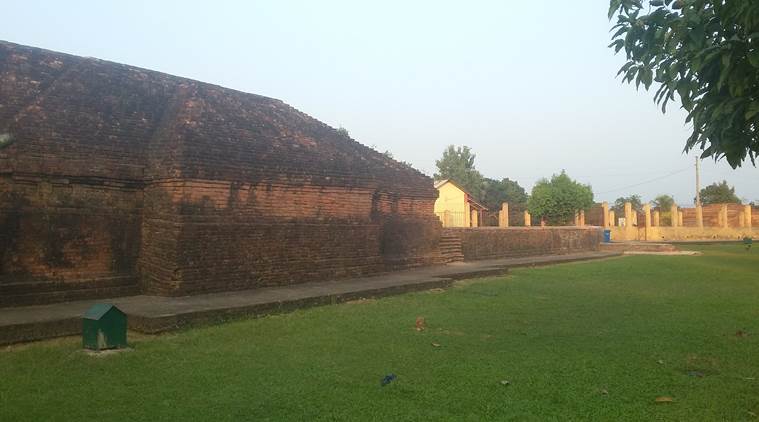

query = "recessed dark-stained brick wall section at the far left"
(0, 176), (142, 283)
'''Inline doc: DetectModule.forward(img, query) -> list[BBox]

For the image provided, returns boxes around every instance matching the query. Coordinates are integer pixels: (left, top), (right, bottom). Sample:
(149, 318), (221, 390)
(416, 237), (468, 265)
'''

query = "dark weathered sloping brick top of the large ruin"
(0, 41), (435, 196)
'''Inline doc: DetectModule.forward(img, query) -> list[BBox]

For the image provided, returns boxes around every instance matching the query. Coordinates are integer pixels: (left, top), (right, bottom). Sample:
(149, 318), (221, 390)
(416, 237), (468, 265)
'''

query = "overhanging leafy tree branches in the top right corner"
(609, 0), (759, 168)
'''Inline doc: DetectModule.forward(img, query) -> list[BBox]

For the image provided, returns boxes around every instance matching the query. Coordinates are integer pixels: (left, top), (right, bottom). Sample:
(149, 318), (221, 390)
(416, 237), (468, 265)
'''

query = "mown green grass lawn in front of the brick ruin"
(0, 245), (759, 421)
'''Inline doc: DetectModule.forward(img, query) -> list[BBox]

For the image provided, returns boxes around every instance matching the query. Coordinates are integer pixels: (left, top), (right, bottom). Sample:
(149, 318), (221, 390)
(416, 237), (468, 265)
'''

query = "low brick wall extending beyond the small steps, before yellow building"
(445, 227), (603, 261)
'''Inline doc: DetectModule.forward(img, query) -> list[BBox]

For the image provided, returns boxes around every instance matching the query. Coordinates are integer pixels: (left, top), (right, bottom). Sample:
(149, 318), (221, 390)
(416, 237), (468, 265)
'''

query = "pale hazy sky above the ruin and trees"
(0, 0), (759, 204)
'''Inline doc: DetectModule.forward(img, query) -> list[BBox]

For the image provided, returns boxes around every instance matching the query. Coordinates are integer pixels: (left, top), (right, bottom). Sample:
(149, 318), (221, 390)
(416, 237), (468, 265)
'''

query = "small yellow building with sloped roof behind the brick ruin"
(435, 179), (487, 227)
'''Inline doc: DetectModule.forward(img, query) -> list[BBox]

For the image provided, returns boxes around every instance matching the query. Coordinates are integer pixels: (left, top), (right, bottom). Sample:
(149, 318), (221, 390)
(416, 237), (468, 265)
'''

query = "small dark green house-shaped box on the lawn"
(82, 303), (127, 350)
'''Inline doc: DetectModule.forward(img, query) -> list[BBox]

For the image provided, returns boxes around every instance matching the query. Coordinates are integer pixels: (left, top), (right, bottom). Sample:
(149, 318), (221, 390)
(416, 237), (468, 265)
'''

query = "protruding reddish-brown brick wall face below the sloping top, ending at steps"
(140, 180), (440, 295)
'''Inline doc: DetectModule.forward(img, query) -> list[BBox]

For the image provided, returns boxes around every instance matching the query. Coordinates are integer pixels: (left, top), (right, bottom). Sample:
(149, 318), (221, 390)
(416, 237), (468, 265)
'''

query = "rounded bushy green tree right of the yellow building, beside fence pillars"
(527, 171), (593, 225)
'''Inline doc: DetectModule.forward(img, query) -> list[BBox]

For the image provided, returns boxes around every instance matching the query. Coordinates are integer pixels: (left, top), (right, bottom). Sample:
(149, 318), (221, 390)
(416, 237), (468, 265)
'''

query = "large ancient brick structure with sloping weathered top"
(0, 42), (441, 304)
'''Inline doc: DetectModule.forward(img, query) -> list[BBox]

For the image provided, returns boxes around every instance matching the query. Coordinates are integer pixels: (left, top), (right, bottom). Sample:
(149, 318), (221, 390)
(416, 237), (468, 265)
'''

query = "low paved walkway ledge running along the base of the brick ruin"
(0, 252), (621, 345)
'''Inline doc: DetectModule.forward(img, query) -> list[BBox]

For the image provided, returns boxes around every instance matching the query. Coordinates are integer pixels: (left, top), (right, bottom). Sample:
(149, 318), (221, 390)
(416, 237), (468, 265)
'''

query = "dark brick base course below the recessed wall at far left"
(0, 277), (140, 308)
